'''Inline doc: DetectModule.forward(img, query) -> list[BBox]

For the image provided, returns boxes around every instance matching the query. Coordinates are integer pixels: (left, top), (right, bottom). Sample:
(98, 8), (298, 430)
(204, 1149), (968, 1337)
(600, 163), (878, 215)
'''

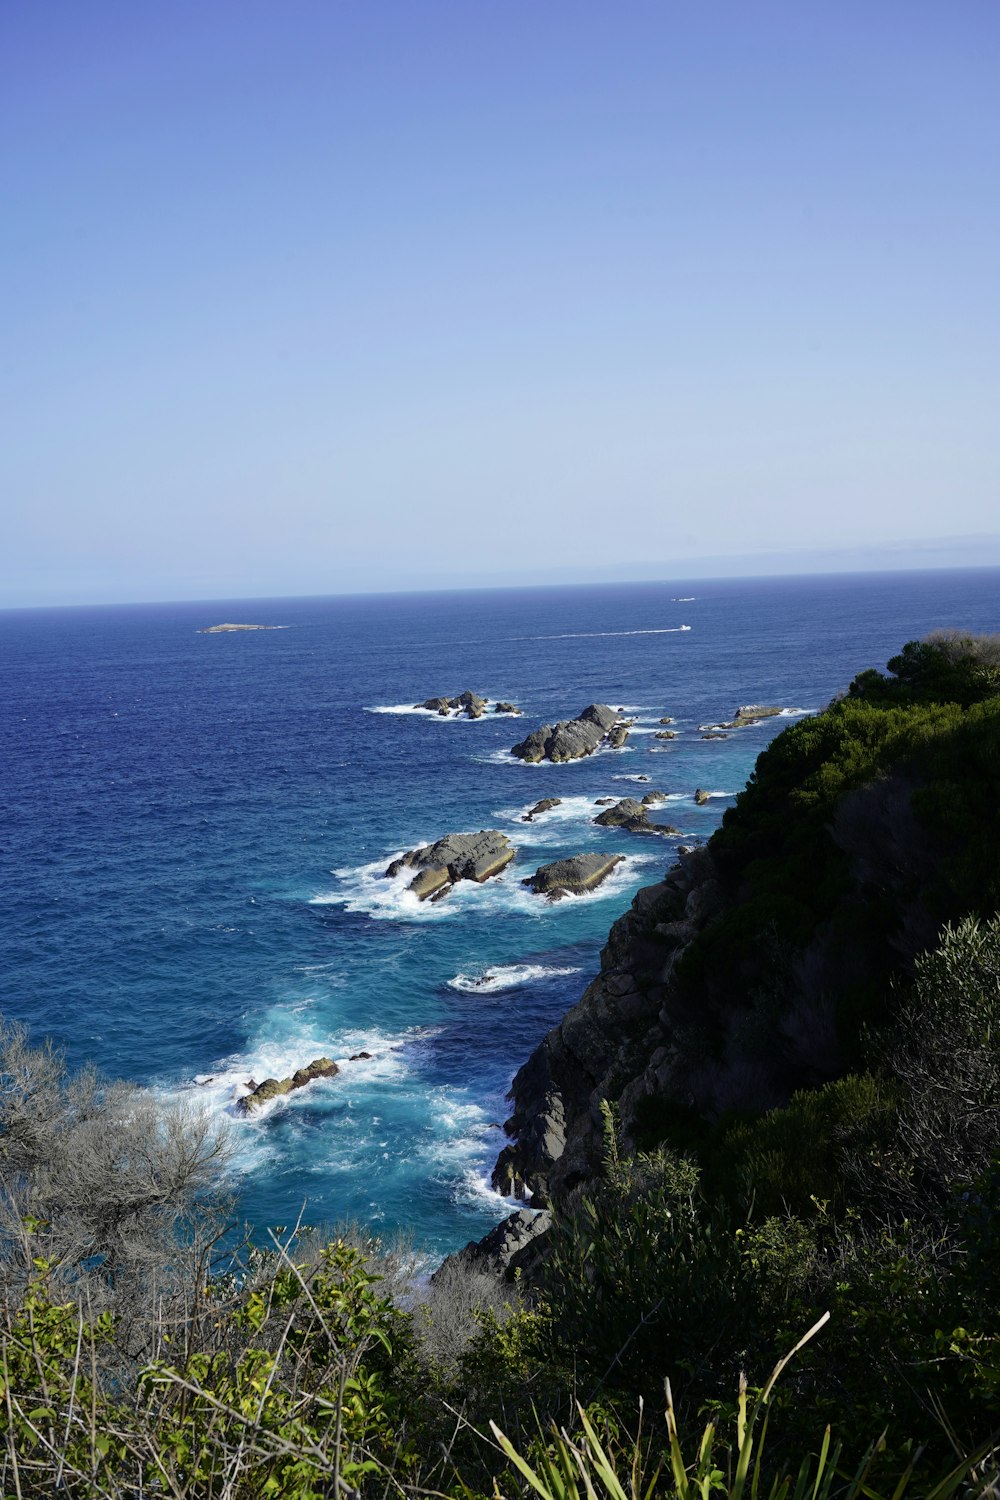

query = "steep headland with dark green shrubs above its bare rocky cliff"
(493, 633), (1000, 1206)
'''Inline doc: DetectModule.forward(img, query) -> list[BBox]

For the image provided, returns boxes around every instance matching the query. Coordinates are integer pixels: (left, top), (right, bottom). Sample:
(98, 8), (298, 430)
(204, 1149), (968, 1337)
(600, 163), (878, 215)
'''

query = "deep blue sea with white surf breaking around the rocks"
(0, 569), (1000, 1254)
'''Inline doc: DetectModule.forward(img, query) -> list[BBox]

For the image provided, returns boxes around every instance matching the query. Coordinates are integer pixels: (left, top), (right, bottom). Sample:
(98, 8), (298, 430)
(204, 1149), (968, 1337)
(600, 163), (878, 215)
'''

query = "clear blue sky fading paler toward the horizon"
(0, 0), (1000, 605)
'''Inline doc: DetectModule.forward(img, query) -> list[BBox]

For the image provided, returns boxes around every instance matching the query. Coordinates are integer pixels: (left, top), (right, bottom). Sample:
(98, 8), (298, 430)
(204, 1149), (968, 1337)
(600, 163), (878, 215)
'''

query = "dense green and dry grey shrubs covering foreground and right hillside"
(0, 636), (1000, 1500)
